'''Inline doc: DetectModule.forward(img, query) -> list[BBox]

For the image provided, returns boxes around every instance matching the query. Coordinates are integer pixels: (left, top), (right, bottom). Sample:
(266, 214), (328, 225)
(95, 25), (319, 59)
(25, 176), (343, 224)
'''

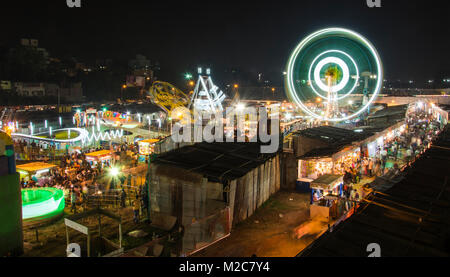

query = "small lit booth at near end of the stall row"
(310, 174), (344, 219)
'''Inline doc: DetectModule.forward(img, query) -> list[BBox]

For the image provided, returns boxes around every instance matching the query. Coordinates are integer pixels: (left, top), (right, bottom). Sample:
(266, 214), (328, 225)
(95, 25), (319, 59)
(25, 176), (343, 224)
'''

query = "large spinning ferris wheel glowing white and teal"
(285, 28), (383, 122)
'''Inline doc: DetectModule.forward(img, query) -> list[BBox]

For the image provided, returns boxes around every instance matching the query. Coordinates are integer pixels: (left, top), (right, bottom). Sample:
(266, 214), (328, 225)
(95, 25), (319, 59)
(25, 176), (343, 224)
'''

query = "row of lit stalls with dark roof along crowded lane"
(294, 121), (406, 218)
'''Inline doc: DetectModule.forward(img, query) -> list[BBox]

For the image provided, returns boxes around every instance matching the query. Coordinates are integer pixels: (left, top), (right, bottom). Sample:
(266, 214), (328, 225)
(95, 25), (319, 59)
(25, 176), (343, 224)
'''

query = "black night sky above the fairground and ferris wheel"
(0, 0), (450, 84)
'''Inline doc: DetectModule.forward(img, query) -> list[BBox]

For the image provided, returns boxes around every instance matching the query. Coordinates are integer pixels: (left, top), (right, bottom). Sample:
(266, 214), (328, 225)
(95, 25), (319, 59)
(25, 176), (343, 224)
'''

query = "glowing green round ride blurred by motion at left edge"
(22, 188), (65, 221)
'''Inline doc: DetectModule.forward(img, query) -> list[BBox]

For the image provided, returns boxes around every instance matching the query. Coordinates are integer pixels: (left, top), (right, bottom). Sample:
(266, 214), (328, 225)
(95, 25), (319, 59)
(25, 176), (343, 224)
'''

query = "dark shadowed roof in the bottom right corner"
(298, 124), (450, 257)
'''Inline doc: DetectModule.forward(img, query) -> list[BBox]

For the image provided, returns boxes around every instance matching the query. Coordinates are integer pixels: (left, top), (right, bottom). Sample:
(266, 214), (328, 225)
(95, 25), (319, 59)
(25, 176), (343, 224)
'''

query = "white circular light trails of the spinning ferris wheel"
(285, 28), (383, 122)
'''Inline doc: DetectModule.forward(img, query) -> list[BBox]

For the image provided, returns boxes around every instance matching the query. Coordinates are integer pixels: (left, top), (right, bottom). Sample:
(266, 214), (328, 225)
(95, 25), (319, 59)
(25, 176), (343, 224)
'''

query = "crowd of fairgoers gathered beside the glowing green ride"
(17, 141), (146, 218)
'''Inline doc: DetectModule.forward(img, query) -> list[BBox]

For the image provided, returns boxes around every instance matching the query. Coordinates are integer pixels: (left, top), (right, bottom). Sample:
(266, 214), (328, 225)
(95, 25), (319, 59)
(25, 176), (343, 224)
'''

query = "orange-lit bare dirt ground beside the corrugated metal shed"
(192, 191), (327, 257)
